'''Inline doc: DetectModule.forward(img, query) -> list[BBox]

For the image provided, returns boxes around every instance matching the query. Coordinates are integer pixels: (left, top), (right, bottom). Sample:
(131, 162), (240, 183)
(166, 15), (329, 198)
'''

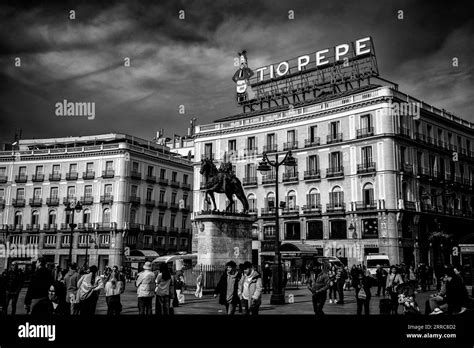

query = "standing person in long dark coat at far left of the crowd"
(25, 257), (54, 313)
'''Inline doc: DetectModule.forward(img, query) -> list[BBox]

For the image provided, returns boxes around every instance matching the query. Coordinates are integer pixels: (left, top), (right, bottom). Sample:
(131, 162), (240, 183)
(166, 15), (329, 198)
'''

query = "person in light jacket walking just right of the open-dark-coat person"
(238, 261), (262, 315)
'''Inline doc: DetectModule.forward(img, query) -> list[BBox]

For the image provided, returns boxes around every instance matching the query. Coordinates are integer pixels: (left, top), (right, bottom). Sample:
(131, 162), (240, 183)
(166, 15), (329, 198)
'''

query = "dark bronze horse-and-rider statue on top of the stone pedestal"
(199, 158), (249, 213)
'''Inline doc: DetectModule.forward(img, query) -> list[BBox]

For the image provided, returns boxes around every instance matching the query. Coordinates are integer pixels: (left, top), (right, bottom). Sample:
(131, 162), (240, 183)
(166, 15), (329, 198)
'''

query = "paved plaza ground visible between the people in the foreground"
(8, 283), (433, 315)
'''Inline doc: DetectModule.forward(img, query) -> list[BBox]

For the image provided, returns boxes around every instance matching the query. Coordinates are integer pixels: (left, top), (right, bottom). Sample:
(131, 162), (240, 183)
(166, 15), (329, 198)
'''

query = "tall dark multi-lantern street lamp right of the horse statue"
(257, 151), (296, 305)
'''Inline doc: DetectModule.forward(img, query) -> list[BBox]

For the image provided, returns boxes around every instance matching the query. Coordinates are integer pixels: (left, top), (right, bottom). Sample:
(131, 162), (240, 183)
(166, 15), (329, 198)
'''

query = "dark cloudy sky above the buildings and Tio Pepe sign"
(0, 0), (474, 141)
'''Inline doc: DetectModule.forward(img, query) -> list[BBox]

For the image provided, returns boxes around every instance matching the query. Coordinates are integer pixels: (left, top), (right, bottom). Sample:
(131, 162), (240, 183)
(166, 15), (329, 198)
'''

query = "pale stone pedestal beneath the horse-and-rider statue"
(194, 214), (256, 266)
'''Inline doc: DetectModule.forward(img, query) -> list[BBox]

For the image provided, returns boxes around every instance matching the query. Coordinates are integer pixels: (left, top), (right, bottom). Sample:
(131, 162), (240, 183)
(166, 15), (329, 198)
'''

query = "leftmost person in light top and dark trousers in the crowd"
(77, 265), (104, 316)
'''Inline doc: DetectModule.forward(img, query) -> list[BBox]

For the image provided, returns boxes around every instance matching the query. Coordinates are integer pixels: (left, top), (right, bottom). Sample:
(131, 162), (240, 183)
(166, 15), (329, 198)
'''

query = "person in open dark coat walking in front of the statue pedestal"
(214, 261), (242, 315)
